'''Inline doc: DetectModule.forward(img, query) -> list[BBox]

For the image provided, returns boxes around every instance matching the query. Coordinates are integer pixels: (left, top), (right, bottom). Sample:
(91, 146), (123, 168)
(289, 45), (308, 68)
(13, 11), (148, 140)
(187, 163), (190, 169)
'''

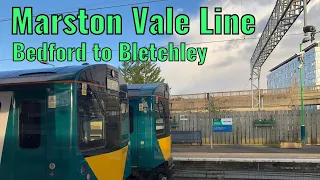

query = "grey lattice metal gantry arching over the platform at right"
(250, 0), (311, 118)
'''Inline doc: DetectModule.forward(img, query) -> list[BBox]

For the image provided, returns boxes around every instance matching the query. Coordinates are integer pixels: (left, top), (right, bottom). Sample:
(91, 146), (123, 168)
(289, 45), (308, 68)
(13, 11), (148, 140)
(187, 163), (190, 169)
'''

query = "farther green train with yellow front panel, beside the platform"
(128, 83), (174, 179)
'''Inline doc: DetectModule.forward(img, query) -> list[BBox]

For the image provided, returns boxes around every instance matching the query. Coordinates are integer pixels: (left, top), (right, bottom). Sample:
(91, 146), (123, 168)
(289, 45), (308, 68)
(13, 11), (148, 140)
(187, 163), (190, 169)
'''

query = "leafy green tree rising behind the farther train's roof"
(119, 61), (164, 84)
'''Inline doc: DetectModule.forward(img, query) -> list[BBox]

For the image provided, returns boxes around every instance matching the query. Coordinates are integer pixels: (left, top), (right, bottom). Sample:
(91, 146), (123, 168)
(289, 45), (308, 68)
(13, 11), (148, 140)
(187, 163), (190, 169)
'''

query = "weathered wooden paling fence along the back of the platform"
(171, 110), (320, 145)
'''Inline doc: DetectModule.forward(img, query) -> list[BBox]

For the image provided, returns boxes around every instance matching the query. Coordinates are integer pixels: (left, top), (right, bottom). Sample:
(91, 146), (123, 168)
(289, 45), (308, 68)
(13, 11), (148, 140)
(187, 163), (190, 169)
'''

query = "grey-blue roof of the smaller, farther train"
(128, 83), (169, 96)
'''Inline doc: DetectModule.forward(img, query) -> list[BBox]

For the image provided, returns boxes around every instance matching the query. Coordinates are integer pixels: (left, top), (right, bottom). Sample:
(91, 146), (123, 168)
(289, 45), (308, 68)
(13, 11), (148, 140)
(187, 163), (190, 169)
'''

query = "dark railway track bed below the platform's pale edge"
(172, 162), (320, 180)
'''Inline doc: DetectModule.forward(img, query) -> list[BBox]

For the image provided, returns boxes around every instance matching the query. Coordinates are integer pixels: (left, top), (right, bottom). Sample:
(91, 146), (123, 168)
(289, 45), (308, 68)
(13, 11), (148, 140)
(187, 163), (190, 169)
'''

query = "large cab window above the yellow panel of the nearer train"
(78, 87), (106, 150)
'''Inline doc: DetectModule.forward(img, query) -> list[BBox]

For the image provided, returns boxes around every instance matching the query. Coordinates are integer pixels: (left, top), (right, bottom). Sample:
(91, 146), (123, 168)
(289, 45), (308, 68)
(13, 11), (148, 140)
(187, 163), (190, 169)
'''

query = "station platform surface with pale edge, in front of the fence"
(172, 145), (320, 163)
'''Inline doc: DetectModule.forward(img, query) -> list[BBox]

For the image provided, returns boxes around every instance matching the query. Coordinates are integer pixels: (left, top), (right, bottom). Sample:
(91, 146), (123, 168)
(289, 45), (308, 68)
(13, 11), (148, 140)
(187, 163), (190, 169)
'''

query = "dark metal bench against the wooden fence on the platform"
(171, 131), (202, 145)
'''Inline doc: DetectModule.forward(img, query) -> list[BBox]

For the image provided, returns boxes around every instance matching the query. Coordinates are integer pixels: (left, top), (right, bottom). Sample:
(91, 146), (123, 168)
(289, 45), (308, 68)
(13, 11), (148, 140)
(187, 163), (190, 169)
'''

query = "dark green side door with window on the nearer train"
(13, 90), (48, 180)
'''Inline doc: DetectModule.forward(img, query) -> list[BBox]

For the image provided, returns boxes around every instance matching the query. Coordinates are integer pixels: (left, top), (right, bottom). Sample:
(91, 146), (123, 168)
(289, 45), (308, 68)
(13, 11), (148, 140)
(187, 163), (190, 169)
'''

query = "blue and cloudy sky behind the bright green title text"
(0, 0), (320, 94)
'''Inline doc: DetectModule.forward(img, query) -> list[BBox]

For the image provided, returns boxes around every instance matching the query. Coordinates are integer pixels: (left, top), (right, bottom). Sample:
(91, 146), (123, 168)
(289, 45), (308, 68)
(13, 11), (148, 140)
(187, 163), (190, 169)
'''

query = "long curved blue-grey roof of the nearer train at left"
(0, 64), (117, 85)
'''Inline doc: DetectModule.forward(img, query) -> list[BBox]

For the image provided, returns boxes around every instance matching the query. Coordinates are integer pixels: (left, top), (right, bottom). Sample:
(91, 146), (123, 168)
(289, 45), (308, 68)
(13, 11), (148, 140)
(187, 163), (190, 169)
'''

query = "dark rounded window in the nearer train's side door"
(19, 101), (41, 149)
